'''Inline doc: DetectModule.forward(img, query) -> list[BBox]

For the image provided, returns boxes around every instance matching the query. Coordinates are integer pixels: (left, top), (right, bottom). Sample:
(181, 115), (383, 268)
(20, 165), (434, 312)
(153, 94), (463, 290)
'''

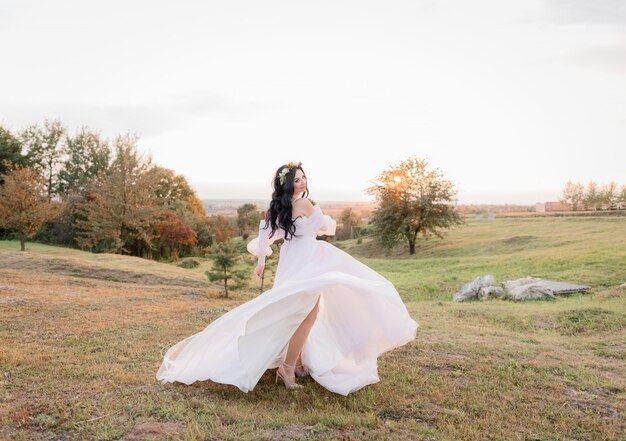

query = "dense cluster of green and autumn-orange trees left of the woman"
(0, 120), (243, 259)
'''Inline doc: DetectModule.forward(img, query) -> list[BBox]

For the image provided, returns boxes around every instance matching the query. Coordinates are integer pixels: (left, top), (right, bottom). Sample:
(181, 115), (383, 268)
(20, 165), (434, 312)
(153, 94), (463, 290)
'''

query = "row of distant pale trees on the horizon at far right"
(560, 181), (626, 211)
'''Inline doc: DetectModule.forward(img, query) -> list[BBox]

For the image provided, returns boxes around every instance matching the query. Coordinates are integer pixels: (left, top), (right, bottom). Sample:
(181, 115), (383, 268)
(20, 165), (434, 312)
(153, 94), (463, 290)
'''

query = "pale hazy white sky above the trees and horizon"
(0, 0), (626, 204)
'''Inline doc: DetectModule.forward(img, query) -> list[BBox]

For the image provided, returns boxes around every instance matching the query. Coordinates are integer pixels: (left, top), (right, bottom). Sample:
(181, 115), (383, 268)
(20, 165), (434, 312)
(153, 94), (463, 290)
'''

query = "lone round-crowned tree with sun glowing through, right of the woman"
(367, 157), (463, 254)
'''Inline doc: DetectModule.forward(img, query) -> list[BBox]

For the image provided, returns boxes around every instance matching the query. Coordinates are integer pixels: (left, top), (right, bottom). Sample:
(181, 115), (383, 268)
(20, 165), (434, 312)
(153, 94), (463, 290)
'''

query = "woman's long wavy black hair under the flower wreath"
(265, 164), (309, 240)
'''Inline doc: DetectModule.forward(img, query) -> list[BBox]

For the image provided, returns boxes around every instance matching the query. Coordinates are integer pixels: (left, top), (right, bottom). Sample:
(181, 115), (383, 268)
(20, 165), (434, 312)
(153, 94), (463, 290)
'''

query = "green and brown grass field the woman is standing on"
(0, 218), (626, 440)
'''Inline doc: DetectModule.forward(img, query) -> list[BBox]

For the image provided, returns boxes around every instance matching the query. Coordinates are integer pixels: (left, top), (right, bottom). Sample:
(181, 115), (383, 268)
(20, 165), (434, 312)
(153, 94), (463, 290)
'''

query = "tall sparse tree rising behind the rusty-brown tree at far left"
(20, 120), (66, 202)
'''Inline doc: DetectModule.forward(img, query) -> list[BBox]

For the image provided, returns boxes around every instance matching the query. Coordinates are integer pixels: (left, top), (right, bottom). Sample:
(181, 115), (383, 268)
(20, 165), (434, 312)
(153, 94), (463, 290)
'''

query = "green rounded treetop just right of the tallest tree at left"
(59, 127), (111, 196)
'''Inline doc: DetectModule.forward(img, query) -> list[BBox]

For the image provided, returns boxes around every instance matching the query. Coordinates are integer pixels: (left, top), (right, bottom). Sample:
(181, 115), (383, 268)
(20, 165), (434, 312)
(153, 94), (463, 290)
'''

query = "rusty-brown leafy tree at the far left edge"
(0, 164), (56, 251)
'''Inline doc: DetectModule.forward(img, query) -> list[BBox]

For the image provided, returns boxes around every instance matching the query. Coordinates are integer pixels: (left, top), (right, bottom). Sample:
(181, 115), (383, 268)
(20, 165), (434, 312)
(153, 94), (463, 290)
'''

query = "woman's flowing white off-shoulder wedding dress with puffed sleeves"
(156, 205), (418, 395)
